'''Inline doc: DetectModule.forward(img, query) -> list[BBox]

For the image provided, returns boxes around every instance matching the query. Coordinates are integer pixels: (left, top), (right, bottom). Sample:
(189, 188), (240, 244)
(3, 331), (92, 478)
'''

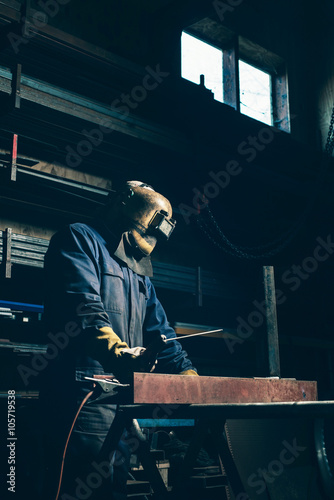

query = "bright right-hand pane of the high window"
(239, 61), (272, 125)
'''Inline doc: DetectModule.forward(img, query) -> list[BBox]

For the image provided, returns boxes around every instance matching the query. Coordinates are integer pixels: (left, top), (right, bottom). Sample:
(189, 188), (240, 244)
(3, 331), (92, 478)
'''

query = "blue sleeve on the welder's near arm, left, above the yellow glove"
(45, 225), (110, 331)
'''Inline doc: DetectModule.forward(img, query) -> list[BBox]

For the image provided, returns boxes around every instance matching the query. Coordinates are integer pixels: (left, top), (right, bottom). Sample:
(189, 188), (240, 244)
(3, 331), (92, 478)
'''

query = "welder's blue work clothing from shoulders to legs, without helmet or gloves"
(40, 222), (194, 500)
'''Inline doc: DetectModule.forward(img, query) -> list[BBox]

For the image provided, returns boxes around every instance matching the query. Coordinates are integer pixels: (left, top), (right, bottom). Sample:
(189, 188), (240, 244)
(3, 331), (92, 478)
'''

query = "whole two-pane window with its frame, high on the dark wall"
(181, 25), (290, 132)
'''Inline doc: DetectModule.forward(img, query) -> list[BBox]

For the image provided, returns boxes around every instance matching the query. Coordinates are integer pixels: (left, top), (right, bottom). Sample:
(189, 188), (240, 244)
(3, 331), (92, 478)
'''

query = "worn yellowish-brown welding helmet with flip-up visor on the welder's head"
(121, 181), (175, 256)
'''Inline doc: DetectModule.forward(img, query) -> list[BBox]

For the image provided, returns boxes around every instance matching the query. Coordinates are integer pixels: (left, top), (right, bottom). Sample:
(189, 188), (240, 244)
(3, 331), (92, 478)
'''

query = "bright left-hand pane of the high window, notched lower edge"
(181, 32), (223, 102)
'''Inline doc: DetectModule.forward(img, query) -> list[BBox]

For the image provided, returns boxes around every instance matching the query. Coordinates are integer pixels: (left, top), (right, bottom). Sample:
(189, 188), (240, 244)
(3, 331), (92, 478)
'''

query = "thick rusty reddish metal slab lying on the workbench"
(133, 373), (318, 404)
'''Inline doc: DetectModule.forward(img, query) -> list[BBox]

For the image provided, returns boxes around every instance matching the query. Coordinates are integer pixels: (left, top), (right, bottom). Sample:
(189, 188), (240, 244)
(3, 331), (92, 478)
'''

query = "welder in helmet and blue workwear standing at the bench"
(40, 181), (197, 500)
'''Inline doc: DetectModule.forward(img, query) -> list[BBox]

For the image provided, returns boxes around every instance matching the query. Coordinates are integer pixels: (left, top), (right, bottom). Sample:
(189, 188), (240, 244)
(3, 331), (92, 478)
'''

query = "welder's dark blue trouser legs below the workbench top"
(43, 386), (130, 500)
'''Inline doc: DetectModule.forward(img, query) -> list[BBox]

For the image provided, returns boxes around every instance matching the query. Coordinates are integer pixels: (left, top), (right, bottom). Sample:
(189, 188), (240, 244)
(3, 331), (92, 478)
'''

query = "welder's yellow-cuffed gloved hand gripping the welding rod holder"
(86, 326), (149, 383)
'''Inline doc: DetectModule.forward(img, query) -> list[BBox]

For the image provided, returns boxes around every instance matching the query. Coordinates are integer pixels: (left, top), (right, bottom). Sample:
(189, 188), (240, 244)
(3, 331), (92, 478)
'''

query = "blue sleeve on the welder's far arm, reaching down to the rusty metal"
(143, 278), (195, 373)
